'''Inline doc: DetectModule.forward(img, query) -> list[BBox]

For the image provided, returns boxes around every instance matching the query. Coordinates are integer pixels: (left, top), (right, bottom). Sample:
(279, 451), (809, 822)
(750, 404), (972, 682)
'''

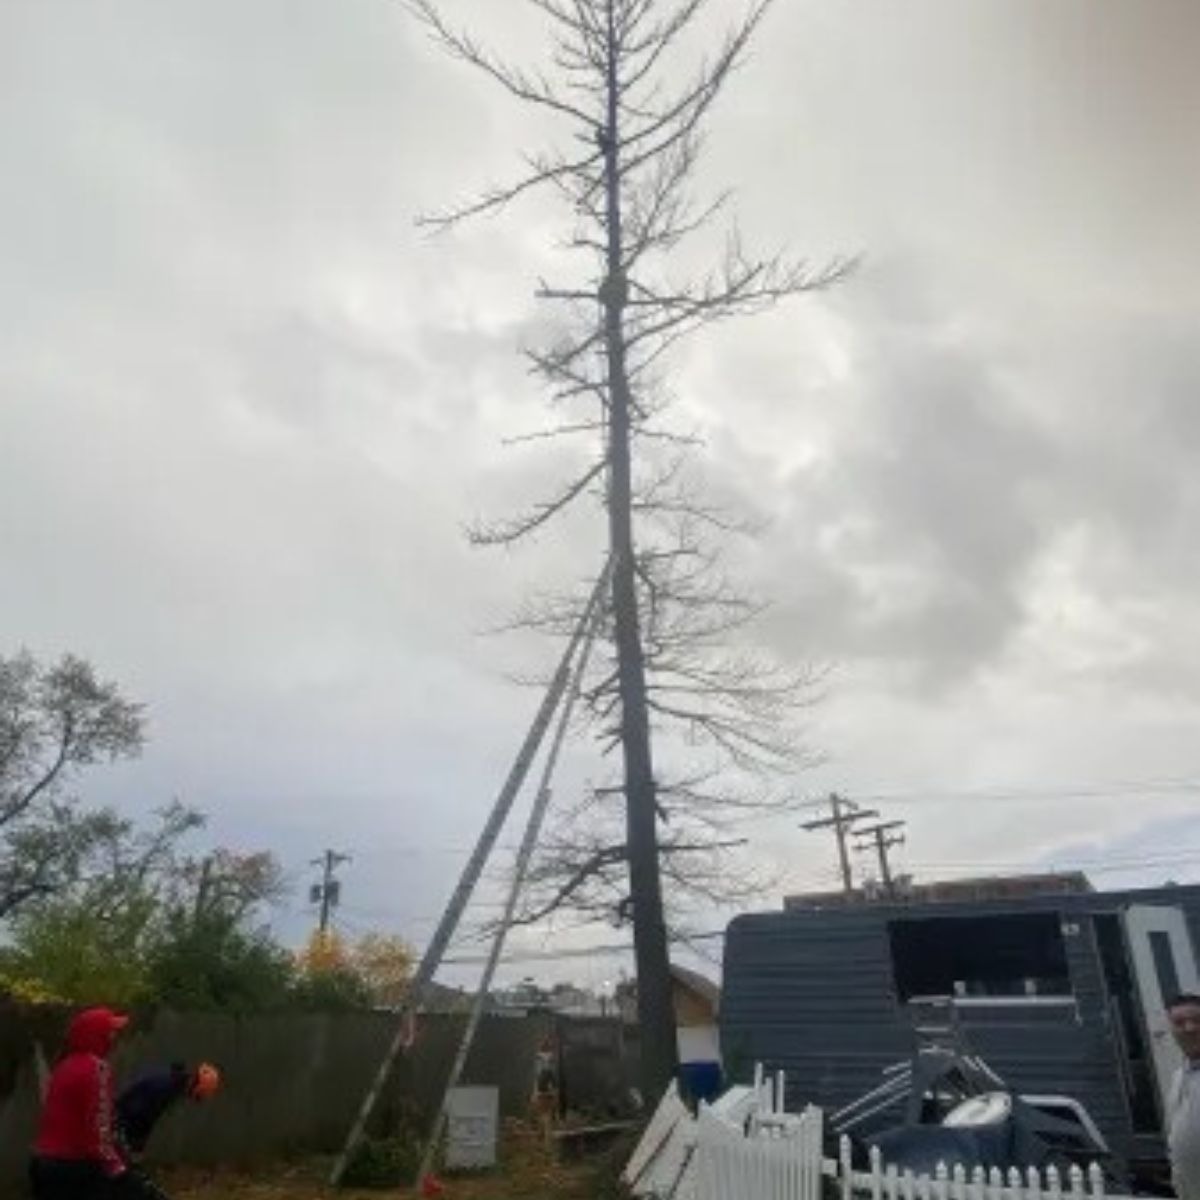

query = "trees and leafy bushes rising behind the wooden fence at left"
(0, 652), (412, 1010)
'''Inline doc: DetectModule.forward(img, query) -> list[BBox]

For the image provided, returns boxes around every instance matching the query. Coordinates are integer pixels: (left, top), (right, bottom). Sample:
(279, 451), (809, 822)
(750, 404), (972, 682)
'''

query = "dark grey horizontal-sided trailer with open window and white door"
(720, 876), (1200, 1164)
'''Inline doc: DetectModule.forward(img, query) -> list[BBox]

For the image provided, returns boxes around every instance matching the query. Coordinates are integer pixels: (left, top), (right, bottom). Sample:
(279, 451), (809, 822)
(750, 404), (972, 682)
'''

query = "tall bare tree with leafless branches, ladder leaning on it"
(409, 0), (848, 1094)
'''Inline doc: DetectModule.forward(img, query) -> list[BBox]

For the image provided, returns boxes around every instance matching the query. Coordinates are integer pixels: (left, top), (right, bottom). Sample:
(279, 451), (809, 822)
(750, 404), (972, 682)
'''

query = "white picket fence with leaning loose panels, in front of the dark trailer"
(625, 1072), (1132, 1200)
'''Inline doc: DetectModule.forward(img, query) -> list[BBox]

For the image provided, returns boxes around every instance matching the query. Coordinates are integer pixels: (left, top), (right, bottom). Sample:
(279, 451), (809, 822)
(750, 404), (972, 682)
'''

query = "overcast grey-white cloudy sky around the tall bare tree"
(0, 0), (1200, 982)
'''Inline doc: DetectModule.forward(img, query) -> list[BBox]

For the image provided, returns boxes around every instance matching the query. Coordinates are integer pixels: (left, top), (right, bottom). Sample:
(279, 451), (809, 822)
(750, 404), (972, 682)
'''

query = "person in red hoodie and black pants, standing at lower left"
(29, 1008), (128, 1200)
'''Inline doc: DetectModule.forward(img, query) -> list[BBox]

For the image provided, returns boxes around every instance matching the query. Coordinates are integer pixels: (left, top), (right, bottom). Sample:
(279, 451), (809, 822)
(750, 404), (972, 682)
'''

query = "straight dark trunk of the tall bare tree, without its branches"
(601, 0), (677, 1104)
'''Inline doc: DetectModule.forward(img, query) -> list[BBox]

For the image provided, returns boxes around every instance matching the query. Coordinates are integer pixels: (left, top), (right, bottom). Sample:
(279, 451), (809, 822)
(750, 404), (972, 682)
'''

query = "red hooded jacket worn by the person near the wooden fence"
(34, 1008), (127, 1175)
